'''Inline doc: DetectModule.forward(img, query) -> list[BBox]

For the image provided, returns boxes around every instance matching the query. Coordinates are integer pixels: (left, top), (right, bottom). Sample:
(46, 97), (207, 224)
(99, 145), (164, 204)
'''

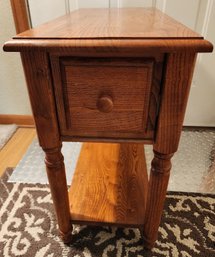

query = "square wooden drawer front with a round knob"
(53, 57), (162, 138)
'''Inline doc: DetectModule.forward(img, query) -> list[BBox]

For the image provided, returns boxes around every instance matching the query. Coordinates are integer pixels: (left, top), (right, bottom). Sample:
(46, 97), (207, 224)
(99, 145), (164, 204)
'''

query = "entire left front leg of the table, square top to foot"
(21, 52), (72, 242)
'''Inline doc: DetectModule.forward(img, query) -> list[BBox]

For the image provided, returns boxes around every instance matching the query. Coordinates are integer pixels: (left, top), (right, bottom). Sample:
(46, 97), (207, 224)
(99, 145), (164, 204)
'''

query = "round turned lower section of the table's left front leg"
(44, 146), (72, 243)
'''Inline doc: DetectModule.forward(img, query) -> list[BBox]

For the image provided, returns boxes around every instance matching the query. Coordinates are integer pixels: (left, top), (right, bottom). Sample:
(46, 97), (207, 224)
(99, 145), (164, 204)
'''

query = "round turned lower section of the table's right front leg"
(143, 151), (173, 249)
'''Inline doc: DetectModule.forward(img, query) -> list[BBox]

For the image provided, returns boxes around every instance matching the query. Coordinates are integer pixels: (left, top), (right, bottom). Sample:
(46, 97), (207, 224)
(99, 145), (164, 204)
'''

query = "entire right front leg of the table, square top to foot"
(140, 53), (196, 248)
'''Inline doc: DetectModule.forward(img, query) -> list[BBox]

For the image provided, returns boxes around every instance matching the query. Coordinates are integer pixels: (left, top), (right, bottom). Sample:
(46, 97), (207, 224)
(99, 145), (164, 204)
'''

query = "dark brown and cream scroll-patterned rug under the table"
(0, 169), (215, 257)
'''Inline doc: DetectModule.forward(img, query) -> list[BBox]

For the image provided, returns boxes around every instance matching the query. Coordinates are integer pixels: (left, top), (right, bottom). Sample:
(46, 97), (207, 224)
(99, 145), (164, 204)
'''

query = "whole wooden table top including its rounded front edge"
(3, 8), (213, 53)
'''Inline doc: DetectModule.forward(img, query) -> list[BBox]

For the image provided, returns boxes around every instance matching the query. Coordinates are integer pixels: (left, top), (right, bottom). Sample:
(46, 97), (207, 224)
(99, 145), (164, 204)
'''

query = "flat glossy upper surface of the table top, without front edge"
(14, 8), (203, 39)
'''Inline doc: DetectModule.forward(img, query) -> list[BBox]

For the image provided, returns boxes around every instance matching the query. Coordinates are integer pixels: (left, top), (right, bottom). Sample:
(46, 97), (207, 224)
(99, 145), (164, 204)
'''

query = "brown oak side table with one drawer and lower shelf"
(4, 8), (213, 248)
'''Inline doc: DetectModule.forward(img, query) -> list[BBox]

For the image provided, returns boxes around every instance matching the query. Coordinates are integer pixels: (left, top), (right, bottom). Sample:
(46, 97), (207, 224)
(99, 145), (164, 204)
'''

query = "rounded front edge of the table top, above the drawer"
(4, 39), (213, 53)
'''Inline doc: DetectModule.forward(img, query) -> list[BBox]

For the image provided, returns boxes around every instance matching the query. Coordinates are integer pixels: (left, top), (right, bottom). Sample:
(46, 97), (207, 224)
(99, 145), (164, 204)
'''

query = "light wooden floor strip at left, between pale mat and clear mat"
(0, 128), (36, 176)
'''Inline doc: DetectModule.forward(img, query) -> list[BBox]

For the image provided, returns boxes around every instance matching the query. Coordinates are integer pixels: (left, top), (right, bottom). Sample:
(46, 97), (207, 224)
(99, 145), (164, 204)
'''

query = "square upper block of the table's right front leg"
(154, 53), (196, 154)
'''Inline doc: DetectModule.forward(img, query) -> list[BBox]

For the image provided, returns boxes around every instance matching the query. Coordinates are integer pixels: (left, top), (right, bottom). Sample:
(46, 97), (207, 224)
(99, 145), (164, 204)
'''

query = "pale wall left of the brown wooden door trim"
(0, 0), (31, 114)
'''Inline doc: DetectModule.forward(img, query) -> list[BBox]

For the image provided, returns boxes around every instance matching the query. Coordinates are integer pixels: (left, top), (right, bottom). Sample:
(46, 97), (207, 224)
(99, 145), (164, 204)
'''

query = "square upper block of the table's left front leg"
(21, 52), (61, 149)
